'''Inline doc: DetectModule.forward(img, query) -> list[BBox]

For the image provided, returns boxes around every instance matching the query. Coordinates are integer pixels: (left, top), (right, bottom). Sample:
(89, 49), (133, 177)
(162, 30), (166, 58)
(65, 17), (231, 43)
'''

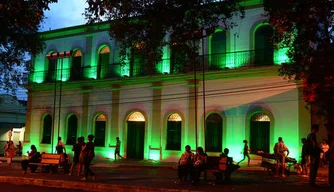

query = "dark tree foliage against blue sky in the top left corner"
(0, 0), (57, 93)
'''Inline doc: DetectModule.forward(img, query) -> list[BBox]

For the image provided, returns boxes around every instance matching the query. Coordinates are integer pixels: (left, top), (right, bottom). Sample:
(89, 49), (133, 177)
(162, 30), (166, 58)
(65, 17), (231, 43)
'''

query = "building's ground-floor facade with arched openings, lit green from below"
(24, 67), (318, 161)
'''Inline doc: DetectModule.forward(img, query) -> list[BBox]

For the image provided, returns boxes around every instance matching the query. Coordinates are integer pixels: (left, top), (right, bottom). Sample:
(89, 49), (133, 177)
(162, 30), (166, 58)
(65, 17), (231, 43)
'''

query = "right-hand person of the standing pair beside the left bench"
(81, 134), (95, 181)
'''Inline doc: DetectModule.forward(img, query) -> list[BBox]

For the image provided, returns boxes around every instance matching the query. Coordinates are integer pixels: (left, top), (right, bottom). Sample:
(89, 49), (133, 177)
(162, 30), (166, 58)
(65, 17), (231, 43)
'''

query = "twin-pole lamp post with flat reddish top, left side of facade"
(46, 51), (73, 153)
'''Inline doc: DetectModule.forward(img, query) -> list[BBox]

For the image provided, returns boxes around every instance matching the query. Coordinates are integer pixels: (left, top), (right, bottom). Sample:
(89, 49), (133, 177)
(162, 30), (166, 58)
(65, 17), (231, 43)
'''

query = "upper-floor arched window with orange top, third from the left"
(97, 46), (110, 79)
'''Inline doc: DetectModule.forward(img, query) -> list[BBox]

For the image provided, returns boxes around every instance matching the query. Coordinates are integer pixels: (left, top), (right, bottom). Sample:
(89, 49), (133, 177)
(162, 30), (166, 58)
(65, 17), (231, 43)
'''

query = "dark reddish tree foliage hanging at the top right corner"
(264, 0), (334, 121)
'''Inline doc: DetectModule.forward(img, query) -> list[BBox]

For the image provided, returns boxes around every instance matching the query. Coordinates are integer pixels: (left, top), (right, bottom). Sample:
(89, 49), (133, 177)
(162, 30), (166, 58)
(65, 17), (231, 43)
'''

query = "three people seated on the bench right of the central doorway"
(175, 145), (235, 184)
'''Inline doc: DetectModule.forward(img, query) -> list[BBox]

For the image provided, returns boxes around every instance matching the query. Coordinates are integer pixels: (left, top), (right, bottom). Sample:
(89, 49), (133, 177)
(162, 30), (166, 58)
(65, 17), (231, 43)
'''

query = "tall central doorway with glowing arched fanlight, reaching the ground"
(126, 112), (145, 159)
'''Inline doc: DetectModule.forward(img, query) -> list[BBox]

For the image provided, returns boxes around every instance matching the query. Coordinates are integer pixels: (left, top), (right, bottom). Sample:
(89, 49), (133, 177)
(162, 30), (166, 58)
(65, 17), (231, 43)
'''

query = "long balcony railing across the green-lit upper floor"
(29, 50), (274, 83)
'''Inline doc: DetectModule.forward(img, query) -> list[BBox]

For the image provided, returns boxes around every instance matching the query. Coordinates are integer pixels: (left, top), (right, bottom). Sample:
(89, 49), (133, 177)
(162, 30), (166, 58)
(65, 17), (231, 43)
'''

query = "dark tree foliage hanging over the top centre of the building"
(85, 0), (244, 74)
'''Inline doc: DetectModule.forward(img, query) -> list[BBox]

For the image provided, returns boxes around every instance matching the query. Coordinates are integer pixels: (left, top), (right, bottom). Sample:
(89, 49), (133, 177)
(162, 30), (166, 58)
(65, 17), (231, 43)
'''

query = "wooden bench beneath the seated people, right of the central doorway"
(203, 156), (227, 181)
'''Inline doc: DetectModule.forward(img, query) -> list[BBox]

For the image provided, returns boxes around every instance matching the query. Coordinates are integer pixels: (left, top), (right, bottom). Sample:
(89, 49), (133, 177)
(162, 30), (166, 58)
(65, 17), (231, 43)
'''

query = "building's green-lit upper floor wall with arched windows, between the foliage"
(29, 5), (288, 83)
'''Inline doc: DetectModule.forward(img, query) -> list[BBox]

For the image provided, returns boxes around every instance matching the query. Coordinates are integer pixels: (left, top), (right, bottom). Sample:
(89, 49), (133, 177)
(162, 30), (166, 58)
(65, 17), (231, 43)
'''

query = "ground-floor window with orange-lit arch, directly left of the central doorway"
(94, 114), (107, 147)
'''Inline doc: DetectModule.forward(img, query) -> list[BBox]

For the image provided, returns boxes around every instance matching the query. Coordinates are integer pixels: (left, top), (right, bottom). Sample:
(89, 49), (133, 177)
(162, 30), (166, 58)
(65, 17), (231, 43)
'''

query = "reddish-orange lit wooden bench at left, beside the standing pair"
(29, 153), (60, 174)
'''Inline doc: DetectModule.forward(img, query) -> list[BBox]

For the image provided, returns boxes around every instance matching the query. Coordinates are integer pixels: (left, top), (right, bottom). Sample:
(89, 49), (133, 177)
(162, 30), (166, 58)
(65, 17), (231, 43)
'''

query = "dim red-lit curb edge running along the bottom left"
(0, 176), (200, 192)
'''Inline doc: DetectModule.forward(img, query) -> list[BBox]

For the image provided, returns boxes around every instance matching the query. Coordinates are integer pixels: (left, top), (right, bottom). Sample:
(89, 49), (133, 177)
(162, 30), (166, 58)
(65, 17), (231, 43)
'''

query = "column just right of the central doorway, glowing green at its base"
(149, 82), (163, 160)
